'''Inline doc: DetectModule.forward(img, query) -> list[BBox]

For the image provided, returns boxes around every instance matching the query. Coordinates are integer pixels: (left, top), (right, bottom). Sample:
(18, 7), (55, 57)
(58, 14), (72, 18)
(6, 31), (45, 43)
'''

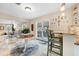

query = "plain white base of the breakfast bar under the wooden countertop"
(63, 34), (75, 56)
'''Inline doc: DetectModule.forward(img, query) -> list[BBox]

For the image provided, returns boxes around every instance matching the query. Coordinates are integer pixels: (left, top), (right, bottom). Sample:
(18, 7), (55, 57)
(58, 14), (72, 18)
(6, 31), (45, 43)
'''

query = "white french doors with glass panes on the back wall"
(37, 21), (49, 41)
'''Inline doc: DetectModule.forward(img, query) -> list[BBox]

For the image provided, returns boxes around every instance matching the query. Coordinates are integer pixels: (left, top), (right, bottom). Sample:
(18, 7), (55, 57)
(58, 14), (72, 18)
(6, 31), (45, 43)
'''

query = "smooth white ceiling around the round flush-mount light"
(0, 3), (73, 19)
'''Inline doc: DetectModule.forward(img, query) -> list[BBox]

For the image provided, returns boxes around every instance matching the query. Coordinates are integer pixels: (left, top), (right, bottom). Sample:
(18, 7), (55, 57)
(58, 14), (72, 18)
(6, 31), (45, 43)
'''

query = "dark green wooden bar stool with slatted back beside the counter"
(47, 30), (63, 56)
